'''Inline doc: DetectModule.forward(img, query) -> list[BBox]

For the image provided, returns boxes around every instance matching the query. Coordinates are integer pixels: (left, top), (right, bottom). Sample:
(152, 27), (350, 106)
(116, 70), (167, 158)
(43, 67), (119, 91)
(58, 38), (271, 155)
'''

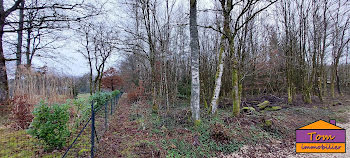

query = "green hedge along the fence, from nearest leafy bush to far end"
(28, 90), (120, 150)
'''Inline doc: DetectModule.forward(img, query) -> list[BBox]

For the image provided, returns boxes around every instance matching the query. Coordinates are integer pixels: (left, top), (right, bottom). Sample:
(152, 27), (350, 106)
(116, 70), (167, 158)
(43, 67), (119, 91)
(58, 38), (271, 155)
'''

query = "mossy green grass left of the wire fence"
(0, 94), (95, 158)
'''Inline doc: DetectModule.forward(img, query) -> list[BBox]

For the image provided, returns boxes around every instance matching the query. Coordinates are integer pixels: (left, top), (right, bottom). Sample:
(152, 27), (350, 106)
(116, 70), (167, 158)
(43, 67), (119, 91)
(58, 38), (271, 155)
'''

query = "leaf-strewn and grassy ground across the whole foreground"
(0, 94), (350, 158)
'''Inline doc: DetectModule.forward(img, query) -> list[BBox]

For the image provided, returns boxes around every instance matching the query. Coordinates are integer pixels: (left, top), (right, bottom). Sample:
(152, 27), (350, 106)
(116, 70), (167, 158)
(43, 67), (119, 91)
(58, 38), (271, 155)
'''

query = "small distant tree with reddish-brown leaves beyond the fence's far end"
(102, 68), (124, 91)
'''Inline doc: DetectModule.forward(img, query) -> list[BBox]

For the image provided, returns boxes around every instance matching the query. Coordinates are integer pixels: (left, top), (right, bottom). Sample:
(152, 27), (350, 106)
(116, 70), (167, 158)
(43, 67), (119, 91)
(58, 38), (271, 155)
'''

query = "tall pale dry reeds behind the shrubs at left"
(10, 67), (73, 104)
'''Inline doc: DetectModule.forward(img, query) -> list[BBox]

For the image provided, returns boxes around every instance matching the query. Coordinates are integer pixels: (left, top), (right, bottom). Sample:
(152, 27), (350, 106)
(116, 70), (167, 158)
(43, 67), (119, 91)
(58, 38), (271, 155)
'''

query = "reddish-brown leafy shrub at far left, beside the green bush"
(10, 96), (33, 130)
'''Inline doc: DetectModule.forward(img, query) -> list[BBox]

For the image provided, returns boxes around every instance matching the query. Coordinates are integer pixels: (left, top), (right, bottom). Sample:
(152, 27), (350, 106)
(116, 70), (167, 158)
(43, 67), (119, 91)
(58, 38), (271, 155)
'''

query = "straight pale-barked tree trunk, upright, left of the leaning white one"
(190, 0), (200, 125)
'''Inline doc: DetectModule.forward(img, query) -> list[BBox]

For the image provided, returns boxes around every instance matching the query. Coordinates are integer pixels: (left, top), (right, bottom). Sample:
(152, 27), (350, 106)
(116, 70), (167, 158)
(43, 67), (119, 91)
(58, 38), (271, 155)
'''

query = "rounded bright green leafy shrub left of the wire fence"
(28, 101), (70, 150)
